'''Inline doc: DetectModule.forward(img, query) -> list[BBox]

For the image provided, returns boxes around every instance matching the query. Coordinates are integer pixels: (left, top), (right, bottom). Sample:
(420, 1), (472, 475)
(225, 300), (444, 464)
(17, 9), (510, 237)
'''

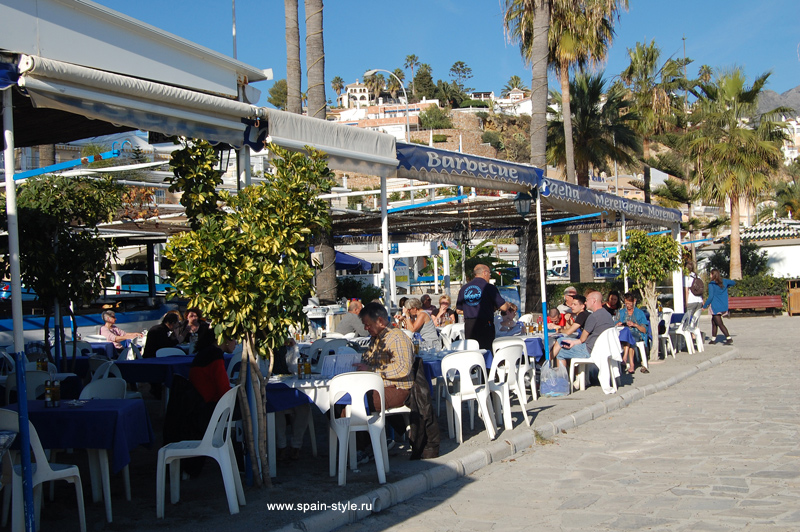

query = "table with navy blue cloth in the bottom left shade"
(6, 399), (155, 523)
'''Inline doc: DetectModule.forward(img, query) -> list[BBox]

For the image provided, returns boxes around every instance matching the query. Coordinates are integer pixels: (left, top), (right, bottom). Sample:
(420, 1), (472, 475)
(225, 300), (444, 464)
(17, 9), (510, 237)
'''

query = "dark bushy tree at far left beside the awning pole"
(2, 175), (123, 362)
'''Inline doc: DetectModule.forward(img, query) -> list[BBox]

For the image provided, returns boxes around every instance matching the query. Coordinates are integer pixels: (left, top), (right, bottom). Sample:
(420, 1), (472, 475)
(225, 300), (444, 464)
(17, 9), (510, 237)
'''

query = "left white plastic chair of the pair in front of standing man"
(442, 351), (496, 443)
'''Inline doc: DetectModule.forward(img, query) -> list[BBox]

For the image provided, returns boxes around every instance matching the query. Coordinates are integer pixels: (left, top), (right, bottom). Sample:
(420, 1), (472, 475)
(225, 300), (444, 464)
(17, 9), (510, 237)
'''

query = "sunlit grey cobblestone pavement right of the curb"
(340, 316), (800, 532)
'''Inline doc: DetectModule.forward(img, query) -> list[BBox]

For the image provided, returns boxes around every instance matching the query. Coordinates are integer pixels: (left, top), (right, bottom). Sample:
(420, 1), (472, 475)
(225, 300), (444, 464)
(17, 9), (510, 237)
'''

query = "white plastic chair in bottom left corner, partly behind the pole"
(0, 410), (86, 532)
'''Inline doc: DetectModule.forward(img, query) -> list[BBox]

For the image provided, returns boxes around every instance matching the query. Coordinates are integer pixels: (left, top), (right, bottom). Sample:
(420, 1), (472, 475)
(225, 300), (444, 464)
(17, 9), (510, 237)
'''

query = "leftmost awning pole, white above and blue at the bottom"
(3, 88), (36, 532)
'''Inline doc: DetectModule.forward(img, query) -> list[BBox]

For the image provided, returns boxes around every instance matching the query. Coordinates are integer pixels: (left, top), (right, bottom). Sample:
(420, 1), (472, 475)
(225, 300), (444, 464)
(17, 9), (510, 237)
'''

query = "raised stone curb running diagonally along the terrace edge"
(276, 348), (739, 532)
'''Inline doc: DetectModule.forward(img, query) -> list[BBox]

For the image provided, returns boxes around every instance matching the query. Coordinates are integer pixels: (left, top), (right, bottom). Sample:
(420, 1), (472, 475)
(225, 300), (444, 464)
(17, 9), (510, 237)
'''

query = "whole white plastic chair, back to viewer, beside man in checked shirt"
(329, 371), (389, 486)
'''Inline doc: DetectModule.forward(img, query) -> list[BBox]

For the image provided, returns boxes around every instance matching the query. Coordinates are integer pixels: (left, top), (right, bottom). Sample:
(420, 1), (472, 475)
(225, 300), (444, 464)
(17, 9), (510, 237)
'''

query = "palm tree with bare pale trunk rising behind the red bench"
(689, 68), (788, 279)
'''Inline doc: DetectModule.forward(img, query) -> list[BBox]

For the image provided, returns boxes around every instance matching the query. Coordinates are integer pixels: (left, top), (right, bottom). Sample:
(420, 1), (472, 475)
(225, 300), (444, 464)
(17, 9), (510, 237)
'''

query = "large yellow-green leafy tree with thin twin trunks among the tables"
(166, 145), (333, 486)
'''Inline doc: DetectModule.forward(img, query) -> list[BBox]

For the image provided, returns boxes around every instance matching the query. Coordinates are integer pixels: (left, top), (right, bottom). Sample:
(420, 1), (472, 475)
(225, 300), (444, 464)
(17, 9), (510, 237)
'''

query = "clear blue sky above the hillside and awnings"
(96, 0), (800, 105)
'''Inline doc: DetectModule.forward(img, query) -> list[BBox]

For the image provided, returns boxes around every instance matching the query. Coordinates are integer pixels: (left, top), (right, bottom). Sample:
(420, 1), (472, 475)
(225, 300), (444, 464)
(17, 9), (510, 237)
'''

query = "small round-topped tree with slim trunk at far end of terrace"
(617, 230), (683, 359)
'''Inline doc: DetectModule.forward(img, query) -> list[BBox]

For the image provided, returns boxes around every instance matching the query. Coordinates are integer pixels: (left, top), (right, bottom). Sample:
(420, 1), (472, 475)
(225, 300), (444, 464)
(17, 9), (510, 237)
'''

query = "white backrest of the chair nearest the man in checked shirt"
(329, 371), (386, 427)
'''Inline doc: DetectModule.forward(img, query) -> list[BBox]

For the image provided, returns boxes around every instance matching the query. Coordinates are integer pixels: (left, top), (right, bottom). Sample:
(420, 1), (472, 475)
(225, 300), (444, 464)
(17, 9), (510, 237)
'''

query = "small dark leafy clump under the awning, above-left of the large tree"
(167, 140), (222, 229)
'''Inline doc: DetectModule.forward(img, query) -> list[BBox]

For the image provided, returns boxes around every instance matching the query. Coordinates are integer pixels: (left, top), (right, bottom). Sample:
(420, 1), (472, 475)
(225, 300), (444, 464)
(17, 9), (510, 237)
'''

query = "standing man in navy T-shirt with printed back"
(456, 264), (509, 350)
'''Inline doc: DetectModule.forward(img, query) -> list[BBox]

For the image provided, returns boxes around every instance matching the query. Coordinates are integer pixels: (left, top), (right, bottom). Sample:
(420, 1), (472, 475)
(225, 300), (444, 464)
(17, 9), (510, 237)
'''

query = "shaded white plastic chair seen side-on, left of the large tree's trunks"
(156, 385), (245, 519)
